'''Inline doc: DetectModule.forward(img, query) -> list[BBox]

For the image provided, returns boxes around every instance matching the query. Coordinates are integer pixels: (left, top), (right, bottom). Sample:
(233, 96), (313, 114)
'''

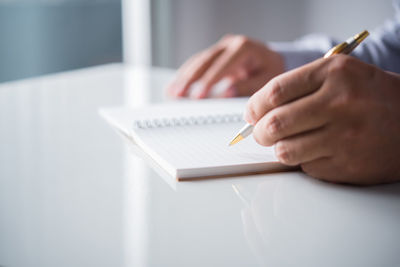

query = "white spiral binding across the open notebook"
(133, 113), (243, 129)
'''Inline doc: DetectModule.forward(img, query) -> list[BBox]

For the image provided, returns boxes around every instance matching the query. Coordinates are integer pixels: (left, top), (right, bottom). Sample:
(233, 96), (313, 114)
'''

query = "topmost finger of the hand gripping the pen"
(245, 59), (327, 125)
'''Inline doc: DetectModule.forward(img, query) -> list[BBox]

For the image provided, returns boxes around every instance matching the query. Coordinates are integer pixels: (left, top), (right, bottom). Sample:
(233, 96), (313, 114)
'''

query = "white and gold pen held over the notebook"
(229, 31), (369, 146)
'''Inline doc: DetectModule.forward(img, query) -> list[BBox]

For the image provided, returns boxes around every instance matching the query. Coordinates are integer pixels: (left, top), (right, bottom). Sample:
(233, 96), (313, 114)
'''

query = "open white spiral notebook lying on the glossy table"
(100, 98), (287, 180)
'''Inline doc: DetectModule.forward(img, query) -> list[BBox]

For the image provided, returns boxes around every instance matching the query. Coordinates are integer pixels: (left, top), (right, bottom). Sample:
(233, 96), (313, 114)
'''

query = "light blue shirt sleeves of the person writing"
(271, 1), (400, 73)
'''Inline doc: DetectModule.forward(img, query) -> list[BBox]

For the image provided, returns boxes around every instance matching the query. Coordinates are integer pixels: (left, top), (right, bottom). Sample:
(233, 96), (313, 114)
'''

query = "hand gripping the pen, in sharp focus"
(245, 55), (400, 184)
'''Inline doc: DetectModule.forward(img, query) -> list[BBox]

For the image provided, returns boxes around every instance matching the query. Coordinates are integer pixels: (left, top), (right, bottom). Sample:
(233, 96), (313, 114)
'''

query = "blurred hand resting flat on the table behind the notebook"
(168, 35), (284, 98)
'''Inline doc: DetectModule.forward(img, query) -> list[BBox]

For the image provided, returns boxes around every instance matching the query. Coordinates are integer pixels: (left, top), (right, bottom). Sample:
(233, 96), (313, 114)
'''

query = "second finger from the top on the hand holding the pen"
(253, 91), (329, 146)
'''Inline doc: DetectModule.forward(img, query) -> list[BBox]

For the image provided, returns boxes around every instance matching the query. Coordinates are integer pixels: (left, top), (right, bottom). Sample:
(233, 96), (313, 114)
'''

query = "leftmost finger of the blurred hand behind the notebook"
(169, 45), (224, 96)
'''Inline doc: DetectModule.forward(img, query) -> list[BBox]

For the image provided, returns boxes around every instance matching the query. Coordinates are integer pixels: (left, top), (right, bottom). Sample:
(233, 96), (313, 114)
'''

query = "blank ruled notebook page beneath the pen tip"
(135, 122), (277, 177)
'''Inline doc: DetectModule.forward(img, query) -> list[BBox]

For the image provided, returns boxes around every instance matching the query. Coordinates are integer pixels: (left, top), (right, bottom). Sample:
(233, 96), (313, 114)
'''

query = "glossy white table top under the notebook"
(0, 64), (400, 267)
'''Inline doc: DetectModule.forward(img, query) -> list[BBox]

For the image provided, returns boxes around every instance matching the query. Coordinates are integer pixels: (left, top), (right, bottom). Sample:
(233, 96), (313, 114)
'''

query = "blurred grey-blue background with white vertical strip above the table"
(0, 0), (393, 82)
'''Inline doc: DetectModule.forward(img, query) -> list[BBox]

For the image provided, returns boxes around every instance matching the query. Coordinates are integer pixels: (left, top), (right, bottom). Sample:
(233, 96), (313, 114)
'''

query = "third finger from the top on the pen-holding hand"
(275, 127), (333, 166)
